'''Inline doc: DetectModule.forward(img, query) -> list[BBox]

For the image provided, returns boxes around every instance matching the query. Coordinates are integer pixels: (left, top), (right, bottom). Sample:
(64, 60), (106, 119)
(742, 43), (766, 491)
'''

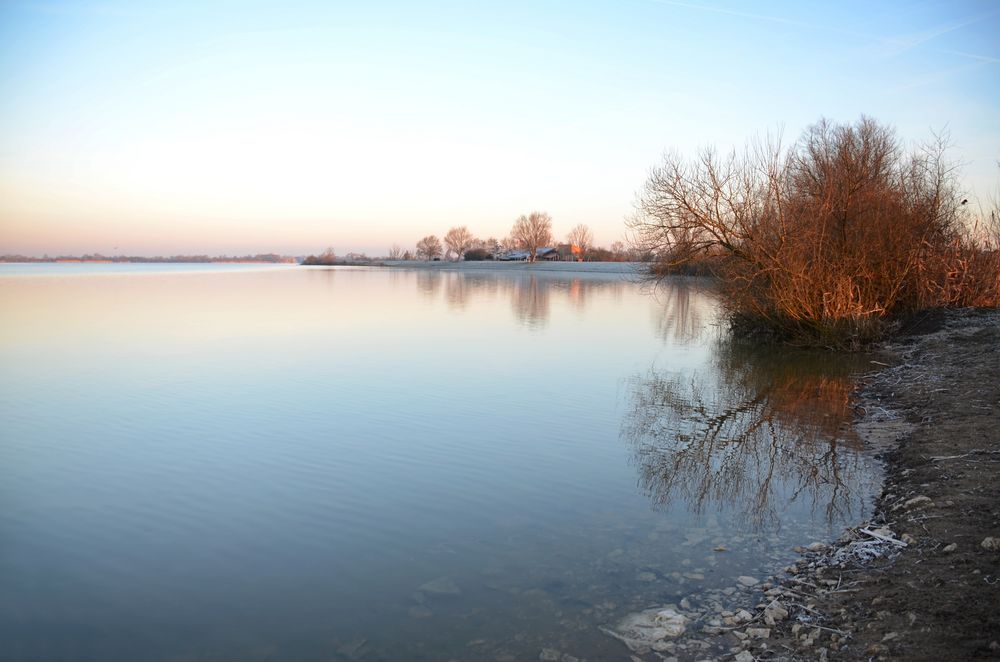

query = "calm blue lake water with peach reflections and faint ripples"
(0, 265), (878, 660)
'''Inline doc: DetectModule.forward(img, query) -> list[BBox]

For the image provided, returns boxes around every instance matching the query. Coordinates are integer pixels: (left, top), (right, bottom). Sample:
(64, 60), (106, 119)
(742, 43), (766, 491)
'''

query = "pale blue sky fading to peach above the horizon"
(0, 0), (1000, 256)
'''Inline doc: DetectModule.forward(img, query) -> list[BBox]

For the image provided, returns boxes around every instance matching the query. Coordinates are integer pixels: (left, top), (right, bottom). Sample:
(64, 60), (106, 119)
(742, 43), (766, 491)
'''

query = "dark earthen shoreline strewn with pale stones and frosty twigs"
(605, 310), (1000, 662)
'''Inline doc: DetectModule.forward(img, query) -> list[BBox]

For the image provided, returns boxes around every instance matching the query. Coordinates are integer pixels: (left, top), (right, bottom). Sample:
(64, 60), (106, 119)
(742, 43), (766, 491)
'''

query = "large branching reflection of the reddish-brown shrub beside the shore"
(622, 341), (875, 529)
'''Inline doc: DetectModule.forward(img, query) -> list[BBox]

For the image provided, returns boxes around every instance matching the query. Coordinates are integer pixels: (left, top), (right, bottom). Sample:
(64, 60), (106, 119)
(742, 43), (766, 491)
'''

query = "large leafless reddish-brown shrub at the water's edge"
(629, 117), (1000, 346)
